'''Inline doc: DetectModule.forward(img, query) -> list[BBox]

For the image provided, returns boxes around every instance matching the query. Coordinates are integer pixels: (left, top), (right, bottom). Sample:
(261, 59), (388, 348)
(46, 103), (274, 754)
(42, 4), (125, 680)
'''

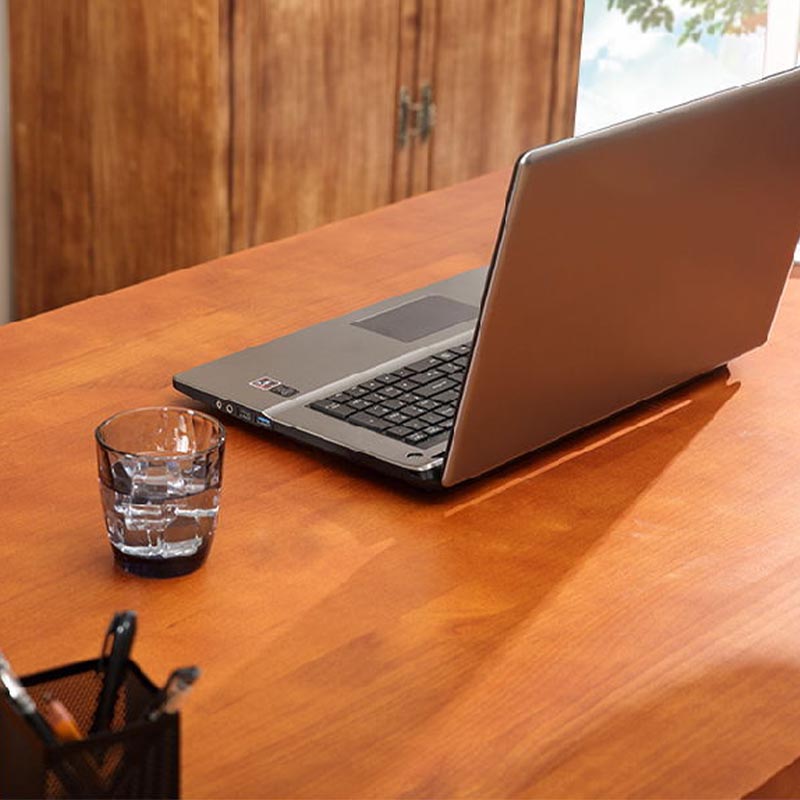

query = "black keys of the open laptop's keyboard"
(308, 344), (472, 447)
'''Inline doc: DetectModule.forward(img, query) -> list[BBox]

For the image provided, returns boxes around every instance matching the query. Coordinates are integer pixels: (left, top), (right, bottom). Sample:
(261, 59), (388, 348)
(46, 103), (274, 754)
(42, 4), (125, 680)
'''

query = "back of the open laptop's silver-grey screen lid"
(443, 70), (800, 486)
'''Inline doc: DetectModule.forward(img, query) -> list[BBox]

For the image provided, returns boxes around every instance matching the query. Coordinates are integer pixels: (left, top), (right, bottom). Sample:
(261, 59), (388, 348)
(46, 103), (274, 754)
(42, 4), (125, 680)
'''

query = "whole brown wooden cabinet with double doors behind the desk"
(9, 0), (582, 316)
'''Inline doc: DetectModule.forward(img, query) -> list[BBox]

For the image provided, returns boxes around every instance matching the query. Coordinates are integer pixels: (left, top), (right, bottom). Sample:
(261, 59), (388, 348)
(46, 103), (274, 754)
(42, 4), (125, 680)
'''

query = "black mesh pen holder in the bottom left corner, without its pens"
(0, 659), (180, 798)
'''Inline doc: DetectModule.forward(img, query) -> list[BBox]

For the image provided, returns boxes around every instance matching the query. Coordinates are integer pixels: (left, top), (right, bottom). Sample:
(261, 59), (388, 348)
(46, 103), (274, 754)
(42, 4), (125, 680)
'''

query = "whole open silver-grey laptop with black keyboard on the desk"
(173, 69), (800, 488)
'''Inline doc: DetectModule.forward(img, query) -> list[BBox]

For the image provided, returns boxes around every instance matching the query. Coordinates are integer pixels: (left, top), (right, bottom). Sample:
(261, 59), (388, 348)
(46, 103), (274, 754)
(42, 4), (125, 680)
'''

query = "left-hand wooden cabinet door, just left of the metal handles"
(231, 0), (401, 249)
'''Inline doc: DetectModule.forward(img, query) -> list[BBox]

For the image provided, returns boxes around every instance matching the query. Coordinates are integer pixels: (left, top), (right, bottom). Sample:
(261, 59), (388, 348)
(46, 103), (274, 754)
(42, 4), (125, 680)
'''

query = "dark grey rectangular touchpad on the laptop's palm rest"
(351, 294), (478, 342)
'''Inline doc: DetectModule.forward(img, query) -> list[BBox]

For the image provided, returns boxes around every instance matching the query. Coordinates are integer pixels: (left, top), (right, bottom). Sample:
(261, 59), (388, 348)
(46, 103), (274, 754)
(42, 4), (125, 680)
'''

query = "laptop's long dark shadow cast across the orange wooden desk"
(202, 370), (738, 797)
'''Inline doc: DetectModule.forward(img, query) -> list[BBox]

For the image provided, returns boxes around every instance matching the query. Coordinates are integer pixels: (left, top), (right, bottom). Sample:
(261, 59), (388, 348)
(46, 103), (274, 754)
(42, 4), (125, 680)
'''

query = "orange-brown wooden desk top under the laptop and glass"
(0, 173), (800, 798)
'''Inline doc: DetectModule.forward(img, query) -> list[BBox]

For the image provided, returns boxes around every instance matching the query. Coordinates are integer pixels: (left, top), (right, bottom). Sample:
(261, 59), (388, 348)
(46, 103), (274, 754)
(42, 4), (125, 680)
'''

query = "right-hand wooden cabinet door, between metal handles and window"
(421, 0), (582, 189)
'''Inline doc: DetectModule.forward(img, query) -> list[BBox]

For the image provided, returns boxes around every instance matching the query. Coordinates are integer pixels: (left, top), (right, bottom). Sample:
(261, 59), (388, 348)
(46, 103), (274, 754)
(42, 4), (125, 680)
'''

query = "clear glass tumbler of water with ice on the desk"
(95, 407), (225, 578)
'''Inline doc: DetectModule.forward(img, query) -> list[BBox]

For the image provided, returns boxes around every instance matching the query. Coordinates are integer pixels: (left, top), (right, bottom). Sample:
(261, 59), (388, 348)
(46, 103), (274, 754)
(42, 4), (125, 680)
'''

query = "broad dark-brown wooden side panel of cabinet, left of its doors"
(9, 0), (228, 316)
